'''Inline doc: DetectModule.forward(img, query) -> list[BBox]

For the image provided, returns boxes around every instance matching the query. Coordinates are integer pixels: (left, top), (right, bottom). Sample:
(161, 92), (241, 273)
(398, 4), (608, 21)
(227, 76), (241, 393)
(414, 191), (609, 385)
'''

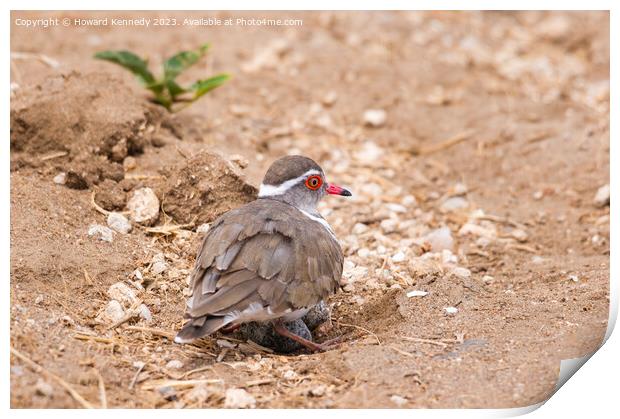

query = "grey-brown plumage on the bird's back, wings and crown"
(175, 156), (348, 343)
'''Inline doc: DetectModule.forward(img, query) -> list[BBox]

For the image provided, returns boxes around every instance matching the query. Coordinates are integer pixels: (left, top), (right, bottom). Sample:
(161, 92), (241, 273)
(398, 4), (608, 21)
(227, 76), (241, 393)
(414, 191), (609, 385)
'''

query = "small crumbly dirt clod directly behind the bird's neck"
(162, 151), (257, 225)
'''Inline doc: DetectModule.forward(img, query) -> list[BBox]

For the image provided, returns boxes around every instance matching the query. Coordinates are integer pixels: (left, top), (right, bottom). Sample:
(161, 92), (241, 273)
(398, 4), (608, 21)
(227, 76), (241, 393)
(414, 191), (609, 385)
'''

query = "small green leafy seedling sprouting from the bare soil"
(95, 44), (230, 111)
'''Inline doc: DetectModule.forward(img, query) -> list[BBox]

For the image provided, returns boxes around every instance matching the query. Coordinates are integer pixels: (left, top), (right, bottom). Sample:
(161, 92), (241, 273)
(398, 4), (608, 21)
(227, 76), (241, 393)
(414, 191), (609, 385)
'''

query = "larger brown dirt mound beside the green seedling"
(11, 71), (167, 185)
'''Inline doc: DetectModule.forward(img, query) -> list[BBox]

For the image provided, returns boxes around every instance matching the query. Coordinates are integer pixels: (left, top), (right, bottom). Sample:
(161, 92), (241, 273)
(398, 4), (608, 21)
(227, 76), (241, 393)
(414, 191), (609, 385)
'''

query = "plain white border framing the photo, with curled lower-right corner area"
(0, 0), (620, 418)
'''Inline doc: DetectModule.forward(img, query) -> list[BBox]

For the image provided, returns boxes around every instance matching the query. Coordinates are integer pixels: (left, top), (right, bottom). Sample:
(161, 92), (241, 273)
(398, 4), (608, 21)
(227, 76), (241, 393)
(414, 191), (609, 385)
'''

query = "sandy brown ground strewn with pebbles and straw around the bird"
(11, 12), (609, 408)
